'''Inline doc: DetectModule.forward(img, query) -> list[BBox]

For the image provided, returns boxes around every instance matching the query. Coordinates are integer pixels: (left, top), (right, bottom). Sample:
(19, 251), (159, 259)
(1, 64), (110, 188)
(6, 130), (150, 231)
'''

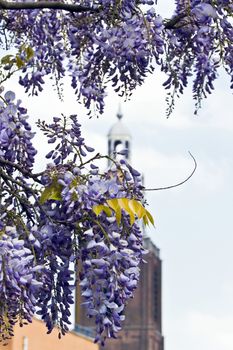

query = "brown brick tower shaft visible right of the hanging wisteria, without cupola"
(101, 237), (163, 350)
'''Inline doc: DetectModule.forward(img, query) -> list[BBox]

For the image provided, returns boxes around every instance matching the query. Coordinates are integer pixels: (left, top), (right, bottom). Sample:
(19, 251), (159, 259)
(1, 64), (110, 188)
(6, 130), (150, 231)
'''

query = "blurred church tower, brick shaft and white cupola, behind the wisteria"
(75, 111), (164, 350)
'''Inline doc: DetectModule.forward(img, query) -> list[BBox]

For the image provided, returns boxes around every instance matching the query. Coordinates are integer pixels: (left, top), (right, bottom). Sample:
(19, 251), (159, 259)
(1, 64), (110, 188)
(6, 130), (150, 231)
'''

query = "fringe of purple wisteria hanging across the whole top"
(0, 0), (230, 114)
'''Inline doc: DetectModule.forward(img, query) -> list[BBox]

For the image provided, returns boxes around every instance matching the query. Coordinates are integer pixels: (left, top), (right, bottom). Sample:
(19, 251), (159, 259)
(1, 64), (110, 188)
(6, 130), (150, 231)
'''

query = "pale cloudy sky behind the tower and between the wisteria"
(3, 1), (233, 350)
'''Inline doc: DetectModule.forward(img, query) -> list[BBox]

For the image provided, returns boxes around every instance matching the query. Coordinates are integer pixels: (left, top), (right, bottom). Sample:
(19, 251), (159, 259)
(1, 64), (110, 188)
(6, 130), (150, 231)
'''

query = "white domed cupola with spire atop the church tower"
(108, 108), (131, 163)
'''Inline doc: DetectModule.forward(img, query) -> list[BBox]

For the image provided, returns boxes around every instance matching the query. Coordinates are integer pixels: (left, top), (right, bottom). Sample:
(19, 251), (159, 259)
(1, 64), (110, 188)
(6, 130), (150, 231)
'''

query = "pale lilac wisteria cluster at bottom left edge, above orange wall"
(0, 228), (43, 342)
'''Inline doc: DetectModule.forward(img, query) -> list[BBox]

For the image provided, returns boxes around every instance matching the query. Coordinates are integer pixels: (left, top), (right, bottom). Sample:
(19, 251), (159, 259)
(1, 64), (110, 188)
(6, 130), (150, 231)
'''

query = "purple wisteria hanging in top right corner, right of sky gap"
(162, 0), (233, 114)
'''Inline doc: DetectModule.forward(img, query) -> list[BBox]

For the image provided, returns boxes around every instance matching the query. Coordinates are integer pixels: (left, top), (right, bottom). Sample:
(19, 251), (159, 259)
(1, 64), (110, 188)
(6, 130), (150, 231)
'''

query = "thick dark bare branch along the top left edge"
(0, 0), (99, 13)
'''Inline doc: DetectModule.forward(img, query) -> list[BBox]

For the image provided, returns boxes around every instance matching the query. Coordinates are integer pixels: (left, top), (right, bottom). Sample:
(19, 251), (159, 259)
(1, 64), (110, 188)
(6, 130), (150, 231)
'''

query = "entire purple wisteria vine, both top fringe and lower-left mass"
(0, 0), (233, 344)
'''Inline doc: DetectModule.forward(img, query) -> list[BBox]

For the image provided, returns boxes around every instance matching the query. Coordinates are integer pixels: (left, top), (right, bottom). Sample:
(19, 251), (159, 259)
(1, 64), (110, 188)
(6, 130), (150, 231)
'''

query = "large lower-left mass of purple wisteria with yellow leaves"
(0, 92), (149, 344)
